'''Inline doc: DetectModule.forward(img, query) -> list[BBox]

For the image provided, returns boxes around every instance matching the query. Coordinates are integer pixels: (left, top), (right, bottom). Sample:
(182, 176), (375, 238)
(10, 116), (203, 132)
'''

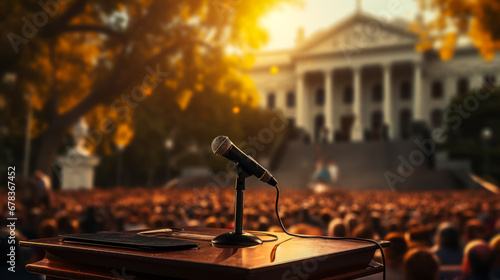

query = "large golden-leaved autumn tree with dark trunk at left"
(0, 0), (293, 173)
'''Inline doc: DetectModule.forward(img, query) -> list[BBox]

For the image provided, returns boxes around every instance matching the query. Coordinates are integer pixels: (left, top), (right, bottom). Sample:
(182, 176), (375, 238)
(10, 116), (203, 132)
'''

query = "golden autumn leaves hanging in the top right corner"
(412, 0), (500, 61)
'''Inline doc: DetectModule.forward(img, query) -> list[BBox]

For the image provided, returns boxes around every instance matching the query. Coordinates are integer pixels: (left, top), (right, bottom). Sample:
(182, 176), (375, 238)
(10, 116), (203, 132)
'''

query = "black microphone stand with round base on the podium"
(212, 168), (262, 247)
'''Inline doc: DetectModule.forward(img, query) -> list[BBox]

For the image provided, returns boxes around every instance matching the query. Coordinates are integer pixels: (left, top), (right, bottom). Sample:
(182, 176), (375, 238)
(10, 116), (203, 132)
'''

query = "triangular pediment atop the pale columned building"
(294, 13), (418, 57)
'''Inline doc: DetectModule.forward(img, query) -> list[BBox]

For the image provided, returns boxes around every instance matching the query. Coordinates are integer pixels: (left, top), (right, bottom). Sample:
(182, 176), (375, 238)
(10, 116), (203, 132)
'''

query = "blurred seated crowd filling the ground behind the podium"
(0, 183), (500, 279)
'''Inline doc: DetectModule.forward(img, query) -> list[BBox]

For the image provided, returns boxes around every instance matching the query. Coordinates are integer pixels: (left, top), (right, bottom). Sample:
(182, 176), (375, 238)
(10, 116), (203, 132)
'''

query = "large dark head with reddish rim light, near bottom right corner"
(462, 239), (493, 279)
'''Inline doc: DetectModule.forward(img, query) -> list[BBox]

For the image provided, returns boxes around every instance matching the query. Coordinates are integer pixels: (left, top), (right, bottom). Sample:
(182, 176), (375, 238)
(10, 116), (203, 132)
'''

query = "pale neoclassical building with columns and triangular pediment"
(251, 12), (500, 143)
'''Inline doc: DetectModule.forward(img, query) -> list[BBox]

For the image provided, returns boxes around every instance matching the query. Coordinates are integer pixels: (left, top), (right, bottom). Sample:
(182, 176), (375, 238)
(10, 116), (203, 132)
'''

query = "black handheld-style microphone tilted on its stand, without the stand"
(212, 135), (278, 186)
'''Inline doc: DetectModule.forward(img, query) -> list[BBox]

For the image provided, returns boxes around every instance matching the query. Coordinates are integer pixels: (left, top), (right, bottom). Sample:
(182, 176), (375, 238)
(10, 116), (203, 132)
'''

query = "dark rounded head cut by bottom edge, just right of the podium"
(403, 248), (439, 280)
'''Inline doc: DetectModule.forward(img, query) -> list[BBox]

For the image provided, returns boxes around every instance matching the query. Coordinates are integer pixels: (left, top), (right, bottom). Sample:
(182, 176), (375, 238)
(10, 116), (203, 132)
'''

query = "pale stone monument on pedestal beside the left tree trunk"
(57, 118), (99, 190)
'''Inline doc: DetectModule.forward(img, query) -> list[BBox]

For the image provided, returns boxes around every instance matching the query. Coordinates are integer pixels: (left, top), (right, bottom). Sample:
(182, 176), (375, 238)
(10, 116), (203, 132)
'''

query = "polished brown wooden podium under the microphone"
(21, 227), (389, 280)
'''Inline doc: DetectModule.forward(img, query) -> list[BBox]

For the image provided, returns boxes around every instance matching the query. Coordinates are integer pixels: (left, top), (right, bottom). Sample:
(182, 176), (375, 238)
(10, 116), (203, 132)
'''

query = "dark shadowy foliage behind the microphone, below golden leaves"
(96, 86), (280, 186)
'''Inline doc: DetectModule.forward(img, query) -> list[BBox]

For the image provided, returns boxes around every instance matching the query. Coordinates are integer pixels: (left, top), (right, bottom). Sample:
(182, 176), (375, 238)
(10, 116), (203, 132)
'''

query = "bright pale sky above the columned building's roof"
(261, 0), (418, 50)
